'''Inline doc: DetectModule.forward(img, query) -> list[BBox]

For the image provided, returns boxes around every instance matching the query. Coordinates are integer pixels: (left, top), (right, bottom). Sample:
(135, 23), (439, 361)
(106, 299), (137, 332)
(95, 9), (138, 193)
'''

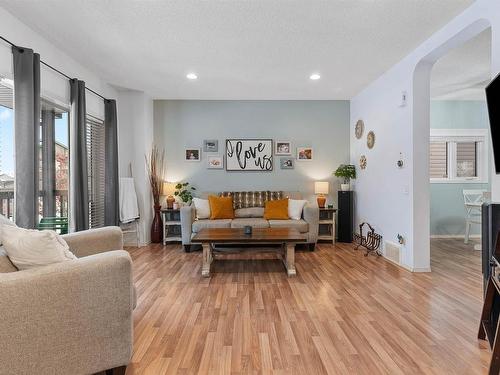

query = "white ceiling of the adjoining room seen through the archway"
(431, 29), (491, 100)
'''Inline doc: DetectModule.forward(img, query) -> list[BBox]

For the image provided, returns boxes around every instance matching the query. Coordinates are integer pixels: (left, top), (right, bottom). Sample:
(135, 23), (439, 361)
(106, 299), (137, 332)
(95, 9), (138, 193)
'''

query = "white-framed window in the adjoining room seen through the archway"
(429, 129), (488, 183)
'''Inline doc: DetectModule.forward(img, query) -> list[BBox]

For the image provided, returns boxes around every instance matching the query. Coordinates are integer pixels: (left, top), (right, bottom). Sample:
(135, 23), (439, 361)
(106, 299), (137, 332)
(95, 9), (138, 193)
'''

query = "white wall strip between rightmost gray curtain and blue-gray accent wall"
(117, 91), (153, 245)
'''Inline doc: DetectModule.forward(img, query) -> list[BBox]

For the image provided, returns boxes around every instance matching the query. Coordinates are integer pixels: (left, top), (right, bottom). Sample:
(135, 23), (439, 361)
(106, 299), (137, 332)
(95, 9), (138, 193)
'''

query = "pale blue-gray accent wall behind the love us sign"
(154, 100), (350, 206)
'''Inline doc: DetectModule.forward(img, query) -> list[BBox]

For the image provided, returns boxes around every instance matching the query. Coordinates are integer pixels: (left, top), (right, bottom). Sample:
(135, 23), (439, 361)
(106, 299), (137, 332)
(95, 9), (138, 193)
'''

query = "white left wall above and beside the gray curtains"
(0, 8), (153, 244)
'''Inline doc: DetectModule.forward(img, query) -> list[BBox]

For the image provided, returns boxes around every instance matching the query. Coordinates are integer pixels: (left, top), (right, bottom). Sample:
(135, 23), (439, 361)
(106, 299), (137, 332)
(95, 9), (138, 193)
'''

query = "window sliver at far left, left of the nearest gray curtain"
(0, 79), (15, 220)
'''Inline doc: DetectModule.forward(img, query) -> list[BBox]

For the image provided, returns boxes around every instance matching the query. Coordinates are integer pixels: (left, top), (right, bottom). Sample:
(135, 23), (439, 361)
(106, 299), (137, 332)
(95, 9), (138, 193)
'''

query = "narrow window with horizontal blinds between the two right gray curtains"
(87, 116), (105, 228)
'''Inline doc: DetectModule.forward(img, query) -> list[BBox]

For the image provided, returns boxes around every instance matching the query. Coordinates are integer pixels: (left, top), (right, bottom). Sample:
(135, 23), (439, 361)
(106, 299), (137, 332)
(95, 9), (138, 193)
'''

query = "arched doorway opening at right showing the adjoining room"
(429, 28), (491, 269)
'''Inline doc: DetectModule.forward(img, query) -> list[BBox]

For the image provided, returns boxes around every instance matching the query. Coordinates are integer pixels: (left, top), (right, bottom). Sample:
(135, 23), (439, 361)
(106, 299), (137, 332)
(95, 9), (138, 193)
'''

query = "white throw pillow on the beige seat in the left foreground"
(1, 225), (76, 270)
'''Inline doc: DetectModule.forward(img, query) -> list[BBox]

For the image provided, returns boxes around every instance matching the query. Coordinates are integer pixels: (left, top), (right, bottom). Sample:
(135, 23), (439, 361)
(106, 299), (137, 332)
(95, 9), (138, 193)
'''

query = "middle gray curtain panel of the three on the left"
(69, 78), (89, 232)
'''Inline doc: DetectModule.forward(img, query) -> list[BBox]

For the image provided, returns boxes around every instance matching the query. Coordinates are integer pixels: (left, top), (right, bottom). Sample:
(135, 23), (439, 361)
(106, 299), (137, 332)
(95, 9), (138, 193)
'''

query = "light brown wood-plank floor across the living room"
(127, 240), (490, 375)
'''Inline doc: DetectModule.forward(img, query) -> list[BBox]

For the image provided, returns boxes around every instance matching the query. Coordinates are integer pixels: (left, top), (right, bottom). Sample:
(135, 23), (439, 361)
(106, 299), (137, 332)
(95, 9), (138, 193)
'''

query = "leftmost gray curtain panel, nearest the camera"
(12, 47), (40, 229)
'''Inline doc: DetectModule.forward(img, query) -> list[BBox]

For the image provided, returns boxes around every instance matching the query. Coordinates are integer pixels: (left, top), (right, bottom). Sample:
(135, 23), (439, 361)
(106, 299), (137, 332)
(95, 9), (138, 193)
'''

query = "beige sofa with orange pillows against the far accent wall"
(181, 191), (319, 252)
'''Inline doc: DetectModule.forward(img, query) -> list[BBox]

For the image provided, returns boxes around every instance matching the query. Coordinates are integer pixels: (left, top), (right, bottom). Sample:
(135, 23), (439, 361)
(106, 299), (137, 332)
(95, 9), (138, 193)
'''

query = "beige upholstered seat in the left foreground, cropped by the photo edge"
(0, 227), (135, 375)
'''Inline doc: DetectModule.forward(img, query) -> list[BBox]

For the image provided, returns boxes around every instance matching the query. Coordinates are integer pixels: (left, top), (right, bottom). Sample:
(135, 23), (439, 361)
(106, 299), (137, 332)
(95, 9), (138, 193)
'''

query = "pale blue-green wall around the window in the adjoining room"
(431, 100), (491, 236)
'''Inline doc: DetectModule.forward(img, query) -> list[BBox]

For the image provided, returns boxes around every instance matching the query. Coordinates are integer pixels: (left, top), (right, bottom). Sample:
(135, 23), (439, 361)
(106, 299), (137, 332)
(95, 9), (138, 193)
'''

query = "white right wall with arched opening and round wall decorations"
(351, 0), (500, 271)
